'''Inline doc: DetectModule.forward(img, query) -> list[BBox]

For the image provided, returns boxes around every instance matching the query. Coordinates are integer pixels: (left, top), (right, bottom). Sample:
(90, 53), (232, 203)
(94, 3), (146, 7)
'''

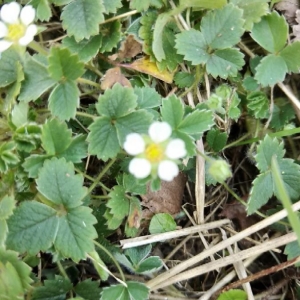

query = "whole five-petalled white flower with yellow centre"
(124, 122), (187, 181)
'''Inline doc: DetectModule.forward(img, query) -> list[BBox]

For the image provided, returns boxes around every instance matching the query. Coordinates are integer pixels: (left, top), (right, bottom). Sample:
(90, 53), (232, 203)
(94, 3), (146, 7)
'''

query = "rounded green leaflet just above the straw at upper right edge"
(254, 54), (288, 86)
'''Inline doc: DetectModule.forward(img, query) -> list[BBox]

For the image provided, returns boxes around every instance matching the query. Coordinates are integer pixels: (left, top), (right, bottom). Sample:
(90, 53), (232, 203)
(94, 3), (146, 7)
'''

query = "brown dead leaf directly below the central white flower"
(141, 173), (186, 218)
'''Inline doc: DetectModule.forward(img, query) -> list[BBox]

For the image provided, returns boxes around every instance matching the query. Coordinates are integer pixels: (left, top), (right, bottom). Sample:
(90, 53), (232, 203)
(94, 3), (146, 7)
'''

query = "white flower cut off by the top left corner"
(0, 2), (37, 53)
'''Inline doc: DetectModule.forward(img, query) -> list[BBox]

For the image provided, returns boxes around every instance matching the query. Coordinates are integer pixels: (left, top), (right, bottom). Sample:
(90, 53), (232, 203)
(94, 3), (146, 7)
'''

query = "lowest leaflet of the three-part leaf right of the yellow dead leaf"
(206, 48), (245, 79)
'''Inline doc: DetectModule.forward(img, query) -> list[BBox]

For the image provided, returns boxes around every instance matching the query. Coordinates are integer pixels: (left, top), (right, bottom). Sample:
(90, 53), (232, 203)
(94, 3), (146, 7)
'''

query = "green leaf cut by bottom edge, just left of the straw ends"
(100, 281), (149, 300)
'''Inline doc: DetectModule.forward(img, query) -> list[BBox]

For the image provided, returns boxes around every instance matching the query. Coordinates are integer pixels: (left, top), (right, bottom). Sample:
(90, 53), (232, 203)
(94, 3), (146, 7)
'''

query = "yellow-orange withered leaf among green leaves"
(121, 57), (174, 83)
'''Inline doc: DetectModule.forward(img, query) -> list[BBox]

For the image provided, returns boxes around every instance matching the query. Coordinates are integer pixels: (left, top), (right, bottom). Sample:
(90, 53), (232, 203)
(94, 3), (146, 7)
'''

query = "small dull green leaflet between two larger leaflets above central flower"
(133, 86), (162, 108)
